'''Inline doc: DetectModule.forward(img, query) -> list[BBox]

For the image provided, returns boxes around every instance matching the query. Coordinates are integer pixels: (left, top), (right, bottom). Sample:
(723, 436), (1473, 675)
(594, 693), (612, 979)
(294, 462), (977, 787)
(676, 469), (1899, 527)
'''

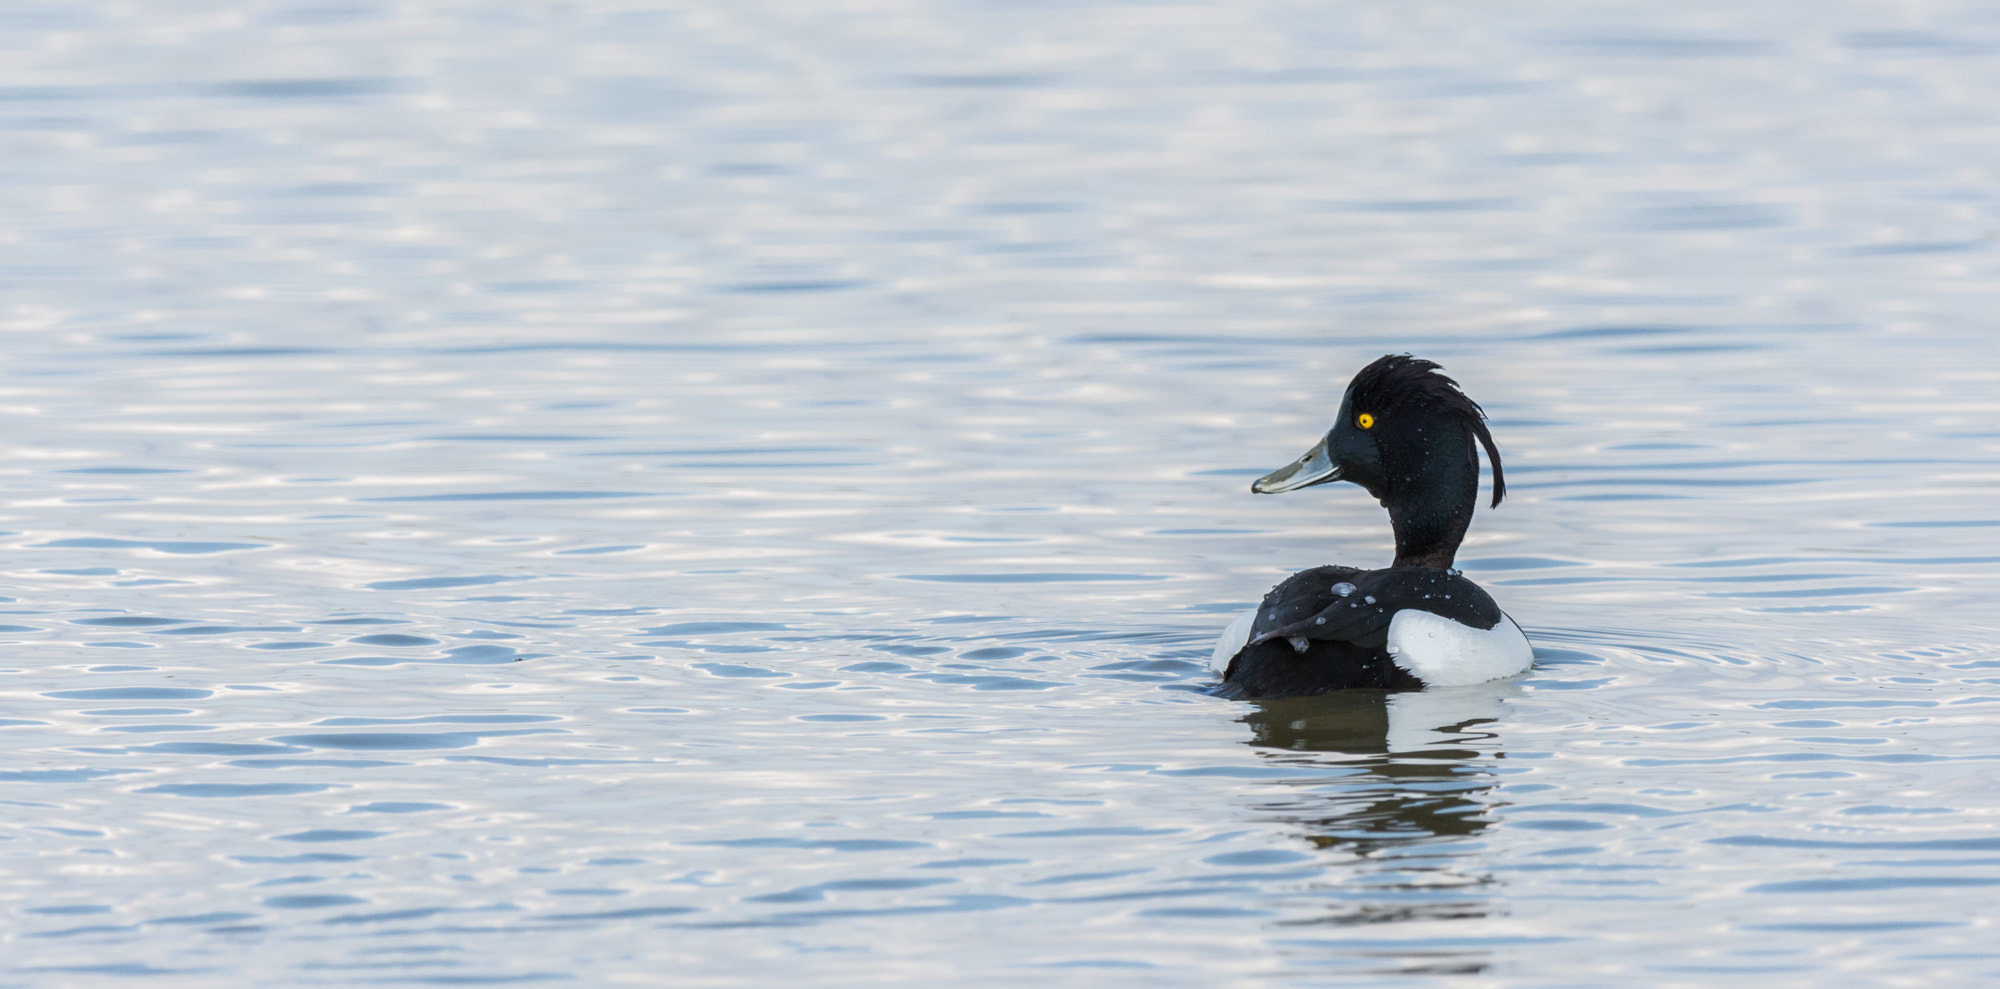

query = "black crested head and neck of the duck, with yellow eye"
(1250, 354), (1506, 567)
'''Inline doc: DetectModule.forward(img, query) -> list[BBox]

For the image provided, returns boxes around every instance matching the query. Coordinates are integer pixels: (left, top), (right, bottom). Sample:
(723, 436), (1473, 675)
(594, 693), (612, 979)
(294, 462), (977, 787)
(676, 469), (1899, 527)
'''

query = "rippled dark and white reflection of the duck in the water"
(1242, 683), (1516, 956)
